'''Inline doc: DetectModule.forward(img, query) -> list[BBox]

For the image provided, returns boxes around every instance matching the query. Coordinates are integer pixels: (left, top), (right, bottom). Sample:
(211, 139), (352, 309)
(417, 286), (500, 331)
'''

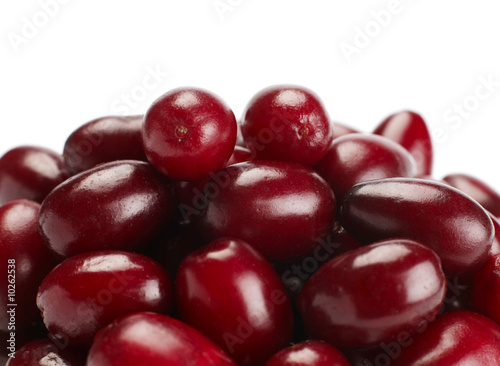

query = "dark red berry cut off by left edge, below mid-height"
(0, 199), (57, 333)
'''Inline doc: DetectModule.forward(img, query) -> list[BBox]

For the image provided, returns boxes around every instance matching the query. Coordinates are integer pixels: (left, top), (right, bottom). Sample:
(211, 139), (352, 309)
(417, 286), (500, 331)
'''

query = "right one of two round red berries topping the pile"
(241, 85), (333, 166)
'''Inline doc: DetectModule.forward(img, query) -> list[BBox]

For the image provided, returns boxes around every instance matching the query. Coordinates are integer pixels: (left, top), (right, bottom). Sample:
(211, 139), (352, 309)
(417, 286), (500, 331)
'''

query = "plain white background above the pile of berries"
(0, 0), (500, 189)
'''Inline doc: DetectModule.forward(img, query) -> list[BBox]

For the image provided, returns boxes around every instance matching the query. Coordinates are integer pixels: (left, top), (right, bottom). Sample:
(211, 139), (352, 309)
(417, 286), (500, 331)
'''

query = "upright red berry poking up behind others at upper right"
(373, 111), (433, 176)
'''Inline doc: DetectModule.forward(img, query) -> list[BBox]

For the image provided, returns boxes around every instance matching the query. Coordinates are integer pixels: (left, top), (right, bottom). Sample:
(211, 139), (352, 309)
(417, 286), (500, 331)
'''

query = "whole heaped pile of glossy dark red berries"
(0, 86), (500, 366)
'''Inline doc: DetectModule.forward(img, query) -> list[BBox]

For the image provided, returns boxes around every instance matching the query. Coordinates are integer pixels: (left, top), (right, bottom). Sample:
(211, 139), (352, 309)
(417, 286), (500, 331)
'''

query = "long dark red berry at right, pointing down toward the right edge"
(340, 178), (494, 279)
